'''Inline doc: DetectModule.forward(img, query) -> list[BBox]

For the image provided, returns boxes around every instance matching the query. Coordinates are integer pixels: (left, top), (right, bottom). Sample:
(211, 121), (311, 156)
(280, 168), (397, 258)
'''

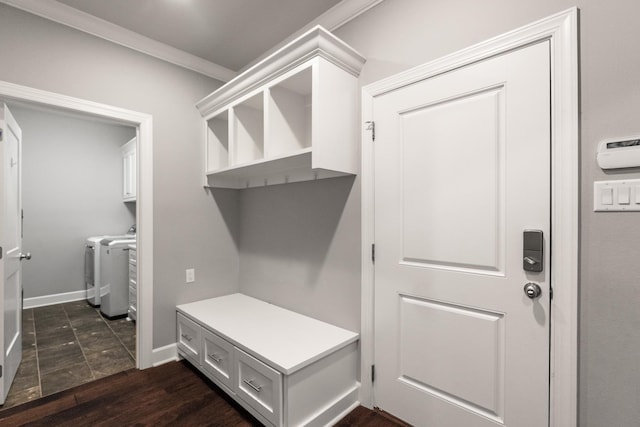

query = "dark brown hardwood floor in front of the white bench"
(0, 362), (405, 427)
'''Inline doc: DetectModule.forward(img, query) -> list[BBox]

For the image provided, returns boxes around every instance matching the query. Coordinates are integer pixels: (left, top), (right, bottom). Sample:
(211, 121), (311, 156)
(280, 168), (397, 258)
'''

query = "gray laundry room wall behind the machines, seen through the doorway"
(9, 104), (135, 298)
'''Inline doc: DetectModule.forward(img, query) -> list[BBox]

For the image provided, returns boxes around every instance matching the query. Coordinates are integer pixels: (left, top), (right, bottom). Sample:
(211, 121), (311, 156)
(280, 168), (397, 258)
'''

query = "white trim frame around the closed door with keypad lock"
(360, 7), (580, 427)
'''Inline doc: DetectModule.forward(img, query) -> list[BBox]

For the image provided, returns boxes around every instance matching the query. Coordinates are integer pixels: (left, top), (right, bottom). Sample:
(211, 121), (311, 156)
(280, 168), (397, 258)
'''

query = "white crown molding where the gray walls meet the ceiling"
(0, 0), (383, 82)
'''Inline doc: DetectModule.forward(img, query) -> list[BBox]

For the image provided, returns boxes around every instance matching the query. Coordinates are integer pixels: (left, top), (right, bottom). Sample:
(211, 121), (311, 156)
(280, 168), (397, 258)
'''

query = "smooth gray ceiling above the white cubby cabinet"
(58, 0), (340, 71)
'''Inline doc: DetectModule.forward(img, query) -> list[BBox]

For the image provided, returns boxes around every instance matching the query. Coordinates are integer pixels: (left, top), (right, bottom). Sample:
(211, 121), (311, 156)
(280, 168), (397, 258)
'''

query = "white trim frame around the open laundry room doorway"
(0, 80), (153, 369)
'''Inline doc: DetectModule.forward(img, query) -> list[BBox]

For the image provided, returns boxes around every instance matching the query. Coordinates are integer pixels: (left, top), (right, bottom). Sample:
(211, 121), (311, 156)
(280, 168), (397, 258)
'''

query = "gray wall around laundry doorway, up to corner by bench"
(0, 4), (239, 348)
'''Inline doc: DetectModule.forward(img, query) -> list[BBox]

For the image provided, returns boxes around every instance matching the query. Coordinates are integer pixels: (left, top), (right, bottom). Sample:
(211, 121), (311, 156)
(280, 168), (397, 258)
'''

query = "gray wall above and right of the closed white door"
(336, 0), (640, 427)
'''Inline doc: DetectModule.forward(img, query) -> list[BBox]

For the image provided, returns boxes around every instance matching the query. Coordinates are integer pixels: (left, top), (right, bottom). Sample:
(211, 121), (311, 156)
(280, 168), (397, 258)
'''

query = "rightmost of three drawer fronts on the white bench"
(235, 348), (282, 425)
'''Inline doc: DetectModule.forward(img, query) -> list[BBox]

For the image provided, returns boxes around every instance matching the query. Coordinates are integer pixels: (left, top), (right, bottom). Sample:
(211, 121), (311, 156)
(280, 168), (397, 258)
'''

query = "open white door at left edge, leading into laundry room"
(0, 104), (22, 403)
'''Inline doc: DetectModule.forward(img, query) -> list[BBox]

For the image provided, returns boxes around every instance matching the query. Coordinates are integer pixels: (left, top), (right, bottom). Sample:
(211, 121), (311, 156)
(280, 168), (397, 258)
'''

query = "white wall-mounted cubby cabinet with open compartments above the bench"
(196, 26), (365, 188)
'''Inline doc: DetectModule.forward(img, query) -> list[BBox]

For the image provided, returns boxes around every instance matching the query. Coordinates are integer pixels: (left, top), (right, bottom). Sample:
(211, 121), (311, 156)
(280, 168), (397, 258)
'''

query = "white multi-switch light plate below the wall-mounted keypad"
(593, 179), (640, 212)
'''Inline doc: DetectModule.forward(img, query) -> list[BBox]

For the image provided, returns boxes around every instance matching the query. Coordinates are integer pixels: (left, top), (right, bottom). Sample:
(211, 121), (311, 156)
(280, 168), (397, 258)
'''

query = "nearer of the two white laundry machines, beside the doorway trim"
(100, 237), (136, 319)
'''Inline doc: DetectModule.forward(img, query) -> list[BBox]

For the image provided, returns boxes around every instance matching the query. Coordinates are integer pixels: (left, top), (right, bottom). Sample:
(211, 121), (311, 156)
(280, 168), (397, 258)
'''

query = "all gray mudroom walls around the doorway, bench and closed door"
(0, 0), (640, 427)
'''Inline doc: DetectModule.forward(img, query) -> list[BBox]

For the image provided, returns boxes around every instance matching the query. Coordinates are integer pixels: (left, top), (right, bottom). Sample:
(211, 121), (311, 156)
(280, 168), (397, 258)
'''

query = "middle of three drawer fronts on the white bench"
(200, 329), (235, 390)
